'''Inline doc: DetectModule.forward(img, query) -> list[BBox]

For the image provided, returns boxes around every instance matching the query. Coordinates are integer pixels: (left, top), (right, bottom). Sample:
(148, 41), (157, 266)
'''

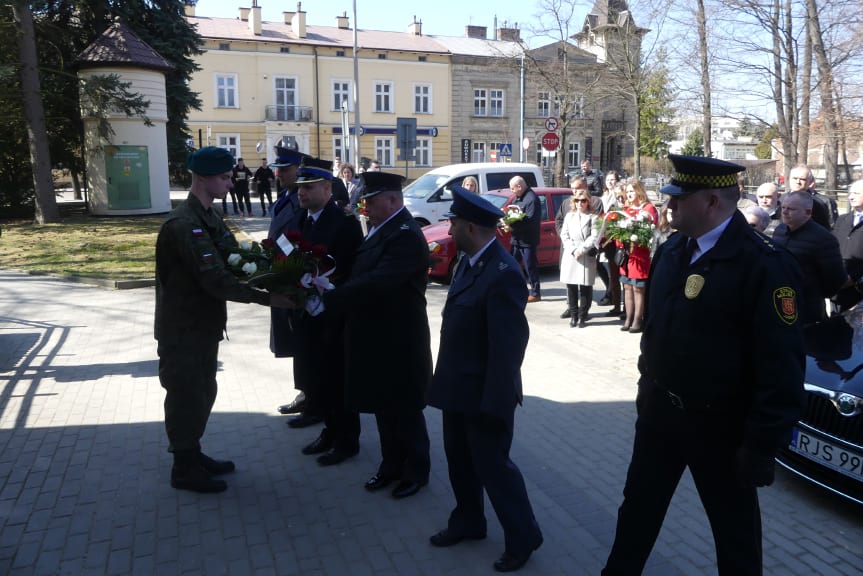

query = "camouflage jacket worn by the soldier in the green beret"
(155, 194), (270, 345)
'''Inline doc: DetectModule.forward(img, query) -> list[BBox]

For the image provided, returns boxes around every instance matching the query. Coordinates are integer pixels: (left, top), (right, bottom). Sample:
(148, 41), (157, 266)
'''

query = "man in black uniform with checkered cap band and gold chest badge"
(602, 154), (805, 576)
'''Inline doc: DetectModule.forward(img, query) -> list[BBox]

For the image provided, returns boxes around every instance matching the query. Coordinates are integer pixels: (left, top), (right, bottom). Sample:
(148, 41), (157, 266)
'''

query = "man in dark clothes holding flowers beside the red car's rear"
(509, 176), (543, 302)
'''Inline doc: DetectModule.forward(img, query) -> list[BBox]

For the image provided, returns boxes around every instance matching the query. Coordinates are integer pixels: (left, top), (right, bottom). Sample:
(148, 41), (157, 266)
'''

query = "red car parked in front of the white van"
(423, 188), (572, 283)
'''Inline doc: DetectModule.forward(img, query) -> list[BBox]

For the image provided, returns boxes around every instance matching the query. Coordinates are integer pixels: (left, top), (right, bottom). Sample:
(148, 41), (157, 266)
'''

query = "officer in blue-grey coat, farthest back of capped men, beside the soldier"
(267, 146), (322, 428)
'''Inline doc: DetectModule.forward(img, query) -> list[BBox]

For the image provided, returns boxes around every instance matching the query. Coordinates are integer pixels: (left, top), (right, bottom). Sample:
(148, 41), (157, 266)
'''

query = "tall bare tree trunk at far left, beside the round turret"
(12, 1), (60, 224)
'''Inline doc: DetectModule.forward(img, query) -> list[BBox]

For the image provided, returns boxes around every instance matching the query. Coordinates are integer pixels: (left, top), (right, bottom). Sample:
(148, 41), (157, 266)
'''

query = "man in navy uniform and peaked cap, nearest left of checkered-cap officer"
(429, 187), (542, 572)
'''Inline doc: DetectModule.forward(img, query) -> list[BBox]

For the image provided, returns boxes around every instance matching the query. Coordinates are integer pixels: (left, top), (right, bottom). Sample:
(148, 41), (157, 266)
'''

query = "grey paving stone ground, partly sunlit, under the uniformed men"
(0, 223), (863, 576)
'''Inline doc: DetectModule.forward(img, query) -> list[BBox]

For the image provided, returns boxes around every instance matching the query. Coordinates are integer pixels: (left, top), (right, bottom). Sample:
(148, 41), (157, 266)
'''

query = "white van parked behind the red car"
(404, 162), (545, 226)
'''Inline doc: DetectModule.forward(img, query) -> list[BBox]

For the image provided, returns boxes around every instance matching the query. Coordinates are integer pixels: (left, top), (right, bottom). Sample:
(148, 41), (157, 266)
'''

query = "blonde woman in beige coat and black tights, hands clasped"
(560, 189), (599, 328)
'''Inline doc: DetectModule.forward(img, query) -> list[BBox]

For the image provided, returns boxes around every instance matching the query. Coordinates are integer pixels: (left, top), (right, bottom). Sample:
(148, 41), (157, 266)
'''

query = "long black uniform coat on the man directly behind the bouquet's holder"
(323, 208), (432, 412)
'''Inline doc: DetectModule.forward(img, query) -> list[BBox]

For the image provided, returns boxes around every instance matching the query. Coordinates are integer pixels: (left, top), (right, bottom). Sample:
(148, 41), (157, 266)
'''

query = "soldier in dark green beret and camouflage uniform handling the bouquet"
(155, 146), (290, 492)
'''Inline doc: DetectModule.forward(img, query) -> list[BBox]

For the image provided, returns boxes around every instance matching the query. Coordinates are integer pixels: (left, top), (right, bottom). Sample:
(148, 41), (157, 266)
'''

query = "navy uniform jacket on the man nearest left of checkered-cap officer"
(429, 241), (529, 421)
